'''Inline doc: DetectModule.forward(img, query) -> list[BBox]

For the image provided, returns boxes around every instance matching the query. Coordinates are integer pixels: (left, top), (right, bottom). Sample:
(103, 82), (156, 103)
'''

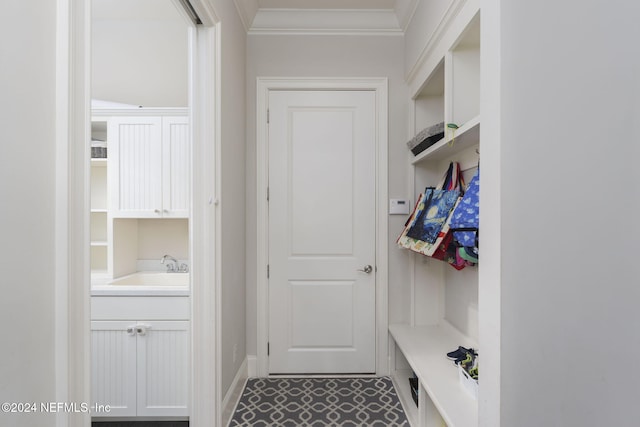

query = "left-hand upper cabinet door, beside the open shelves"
(108, 117), (162, 218)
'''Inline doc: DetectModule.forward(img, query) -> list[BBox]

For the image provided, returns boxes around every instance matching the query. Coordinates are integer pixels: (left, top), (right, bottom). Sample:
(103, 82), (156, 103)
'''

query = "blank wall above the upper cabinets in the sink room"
(91, 0), (189, 107)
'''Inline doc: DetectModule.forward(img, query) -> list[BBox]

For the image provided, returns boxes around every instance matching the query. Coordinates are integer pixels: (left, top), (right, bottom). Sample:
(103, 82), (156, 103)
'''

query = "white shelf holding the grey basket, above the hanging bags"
(411, 116), (480, 165)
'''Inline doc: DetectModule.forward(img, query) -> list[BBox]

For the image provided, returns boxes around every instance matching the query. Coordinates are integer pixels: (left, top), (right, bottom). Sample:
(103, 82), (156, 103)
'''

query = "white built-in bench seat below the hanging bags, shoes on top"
(389, 321), (478, 427)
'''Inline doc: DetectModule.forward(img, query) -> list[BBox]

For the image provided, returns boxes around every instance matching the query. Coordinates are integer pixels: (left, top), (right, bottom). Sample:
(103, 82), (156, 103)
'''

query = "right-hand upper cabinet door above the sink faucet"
(162, 117), (191, 218)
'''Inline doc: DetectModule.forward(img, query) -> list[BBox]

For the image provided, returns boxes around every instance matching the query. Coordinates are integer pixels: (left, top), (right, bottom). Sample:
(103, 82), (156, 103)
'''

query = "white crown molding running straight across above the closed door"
(248, 9), (403, 35)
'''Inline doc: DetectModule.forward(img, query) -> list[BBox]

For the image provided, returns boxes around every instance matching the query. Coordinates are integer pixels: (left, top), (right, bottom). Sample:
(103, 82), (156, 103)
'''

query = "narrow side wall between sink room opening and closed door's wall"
(213, 0), (247, 398)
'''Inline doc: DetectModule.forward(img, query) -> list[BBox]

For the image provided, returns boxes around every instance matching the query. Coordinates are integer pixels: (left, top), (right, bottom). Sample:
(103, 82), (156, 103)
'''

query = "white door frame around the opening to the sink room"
(54, 0), (222, 427)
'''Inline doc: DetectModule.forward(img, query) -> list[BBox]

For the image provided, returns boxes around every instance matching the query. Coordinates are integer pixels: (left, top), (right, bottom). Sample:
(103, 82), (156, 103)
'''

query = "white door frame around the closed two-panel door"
(256, 77), (389, 377)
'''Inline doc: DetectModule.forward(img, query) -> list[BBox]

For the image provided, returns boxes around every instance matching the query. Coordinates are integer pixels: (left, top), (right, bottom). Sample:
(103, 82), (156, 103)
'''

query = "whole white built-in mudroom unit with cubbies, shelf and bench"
(389, 6), (482, 427)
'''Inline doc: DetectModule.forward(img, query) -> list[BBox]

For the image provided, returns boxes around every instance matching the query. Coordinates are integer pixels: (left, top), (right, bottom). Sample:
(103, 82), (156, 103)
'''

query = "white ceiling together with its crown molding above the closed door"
(234, 0), (419, 34)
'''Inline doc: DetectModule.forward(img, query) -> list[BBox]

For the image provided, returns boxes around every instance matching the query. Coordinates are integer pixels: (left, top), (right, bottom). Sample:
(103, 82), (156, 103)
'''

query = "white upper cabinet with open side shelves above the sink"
(90, 112), (191, 285)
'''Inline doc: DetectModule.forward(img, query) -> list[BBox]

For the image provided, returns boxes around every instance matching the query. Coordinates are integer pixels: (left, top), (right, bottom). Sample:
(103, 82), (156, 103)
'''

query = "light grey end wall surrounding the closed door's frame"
(246, 35), (408, 355)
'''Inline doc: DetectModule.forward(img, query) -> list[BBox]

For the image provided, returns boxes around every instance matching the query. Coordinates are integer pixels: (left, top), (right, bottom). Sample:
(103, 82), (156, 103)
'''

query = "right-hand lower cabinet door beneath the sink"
(137, 321), (189, 417)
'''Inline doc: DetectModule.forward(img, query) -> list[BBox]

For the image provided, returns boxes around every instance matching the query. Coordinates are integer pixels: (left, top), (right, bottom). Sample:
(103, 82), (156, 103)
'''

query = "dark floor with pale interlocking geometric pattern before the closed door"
(229, 377), (409, 427)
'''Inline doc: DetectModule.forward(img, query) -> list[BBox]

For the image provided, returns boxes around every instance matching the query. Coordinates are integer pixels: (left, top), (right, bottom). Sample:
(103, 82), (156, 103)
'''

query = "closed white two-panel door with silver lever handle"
(268, 91), (376, 374)
